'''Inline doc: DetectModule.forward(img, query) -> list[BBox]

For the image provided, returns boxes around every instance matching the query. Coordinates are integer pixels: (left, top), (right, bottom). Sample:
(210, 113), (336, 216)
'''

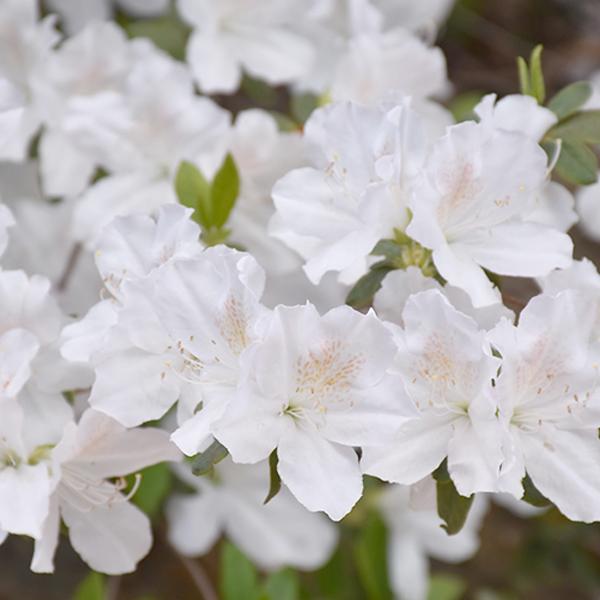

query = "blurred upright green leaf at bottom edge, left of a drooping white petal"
(354, 513), (392, 600)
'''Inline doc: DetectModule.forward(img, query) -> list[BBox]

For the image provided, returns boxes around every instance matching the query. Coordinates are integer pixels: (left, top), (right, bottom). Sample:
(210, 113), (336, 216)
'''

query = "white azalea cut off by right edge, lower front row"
(490, 290), (600, 522)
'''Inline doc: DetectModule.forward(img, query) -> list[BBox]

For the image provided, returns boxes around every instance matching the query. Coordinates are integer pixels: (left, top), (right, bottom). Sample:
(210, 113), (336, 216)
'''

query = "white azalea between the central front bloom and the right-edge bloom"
(361, 290), (502, 496)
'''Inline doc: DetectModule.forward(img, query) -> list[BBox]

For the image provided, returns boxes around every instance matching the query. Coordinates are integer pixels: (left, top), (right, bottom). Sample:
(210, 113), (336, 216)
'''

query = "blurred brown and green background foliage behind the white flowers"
(0, 0), (600, 600)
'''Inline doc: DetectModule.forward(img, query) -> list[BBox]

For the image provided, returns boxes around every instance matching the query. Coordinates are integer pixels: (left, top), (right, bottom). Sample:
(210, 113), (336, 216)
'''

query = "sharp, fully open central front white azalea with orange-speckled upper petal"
(213, 305), (414, 520)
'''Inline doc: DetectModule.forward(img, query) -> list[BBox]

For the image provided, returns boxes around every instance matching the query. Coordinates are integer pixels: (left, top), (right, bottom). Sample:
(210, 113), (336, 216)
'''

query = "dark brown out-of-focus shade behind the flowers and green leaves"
(0, 0), (600, 600)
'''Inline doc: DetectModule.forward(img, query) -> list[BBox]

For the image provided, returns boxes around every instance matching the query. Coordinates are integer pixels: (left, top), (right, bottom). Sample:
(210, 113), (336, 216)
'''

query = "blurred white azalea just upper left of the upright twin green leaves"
(65, 48), (230, 247)
